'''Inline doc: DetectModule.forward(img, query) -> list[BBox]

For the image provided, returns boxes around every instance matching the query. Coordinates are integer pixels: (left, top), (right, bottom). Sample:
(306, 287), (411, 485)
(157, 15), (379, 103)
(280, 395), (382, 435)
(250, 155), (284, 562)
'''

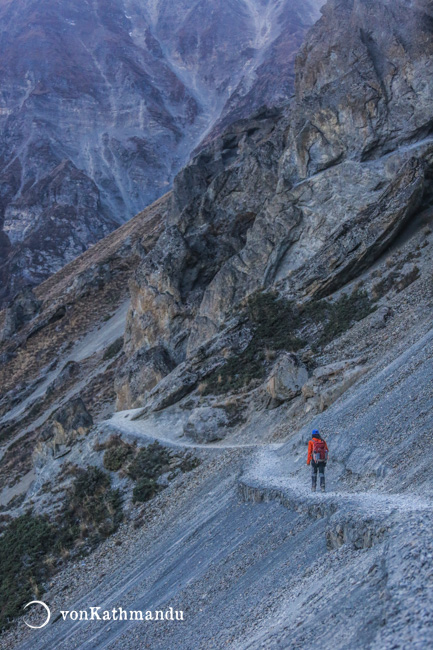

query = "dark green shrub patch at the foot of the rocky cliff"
(201, 288), (374, 394)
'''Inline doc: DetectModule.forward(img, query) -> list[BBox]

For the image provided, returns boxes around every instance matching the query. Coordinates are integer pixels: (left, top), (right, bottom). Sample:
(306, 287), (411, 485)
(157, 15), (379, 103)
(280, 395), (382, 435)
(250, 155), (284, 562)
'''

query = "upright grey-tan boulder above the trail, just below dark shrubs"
(266, 353), (308, 402)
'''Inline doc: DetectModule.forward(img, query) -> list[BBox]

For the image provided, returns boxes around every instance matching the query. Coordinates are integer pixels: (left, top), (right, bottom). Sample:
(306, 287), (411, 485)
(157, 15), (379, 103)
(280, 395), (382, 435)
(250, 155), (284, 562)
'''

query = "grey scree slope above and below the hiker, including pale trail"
(5, 320), (433, 650)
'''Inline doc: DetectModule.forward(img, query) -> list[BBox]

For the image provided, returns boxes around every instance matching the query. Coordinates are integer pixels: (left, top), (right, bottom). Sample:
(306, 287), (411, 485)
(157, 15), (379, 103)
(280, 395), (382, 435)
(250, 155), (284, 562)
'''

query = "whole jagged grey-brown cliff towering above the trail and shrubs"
(118, 0), (433, 406)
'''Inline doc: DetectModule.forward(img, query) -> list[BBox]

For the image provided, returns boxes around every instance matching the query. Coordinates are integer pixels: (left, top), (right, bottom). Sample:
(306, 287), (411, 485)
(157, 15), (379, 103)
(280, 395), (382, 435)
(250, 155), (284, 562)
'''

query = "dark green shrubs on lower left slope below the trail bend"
(0, 436), (199, 629)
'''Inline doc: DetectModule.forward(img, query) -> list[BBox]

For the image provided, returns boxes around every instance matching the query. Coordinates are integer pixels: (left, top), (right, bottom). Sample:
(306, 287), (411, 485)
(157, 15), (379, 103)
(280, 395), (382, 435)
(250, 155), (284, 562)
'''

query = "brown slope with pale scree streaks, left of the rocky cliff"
(0, 190), (167, 498)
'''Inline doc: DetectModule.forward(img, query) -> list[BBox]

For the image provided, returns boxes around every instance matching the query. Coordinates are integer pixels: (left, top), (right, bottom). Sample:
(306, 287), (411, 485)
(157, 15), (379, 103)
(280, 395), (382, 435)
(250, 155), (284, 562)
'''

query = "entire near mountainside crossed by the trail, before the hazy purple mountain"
(0, 0), (433, 650)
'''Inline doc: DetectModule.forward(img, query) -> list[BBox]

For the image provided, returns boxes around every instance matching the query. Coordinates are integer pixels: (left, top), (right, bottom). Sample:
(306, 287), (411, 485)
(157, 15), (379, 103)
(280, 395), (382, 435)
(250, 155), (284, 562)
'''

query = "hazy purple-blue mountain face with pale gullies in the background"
(0, 0), (320, 300)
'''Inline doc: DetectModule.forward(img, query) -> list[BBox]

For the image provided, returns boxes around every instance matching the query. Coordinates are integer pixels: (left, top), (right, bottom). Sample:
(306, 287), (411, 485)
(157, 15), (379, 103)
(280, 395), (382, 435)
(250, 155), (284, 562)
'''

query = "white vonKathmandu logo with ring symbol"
(24, 600), (185, 630)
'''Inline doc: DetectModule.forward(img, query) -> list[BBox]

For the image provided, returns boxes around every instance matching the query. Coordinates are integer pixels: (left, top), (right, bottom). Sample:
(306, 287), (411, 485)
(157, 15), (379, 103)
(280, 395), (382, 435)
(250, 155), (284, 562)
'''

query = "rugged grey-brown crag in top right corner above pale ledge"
(281, 0), (432, 177)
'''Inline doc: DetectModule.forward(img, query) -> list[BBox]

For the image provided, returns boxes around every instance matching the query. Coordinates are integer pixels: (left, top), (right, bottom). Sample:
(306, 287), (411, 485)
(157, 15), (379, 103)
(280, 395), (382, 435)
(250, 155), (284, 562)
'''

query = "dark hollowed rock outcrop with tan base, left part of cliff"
(125, 104), (281, 363)
